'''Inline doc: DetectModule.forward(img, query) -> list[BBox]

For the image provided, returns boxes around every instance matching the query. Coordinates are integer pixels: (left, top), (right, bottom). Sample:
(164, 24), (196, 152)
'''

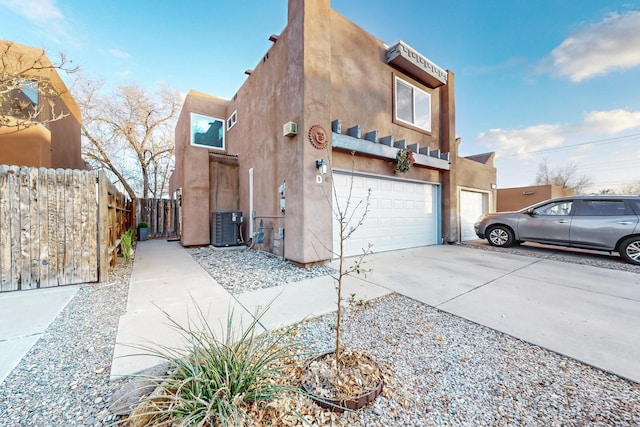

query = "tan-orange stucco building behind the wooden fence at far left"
(0, 40), (88, 169)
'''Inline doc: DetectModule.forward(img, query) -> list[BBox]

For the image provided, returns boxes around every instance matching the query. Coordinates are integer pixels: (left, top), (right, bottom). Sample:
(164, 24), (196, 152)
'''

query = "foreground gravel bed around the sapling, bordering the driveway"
(290, 294), (640, 426)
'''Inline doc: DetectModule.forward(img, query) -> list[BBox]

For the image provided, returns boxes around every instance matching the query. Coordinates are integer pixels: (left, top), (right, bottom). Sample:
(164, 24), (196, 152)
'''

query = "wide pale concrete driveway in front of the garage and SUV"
(342, 246), (640, 382)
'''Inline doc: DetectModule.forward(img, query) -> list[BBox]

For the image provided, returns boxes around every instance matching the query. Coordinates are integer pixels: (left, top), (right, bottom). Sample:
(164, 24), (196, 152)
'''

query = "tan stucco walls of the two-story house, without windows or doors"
(171, 0), (495, 264)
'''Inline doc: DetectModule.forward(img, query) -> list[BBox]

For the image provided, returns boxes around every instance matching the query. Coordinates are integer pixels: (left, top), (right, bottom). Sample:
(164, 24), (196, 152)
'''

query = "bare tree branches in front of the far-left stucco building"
(0, 41), (78, 131)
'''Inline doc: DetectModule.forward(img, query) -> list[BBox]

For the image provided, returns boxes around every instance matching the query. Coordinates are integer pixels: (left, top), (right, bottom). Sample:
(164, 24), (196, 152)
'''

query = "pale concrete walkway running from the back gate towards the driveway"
(111, 240), (391, 378)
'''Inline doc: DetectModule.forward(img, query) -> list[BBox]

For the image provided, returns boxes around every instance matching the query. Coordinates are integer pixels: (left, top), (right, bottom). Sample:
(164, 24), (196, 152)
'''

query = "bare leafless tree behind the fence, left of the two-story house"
(73, 78), (182, 199)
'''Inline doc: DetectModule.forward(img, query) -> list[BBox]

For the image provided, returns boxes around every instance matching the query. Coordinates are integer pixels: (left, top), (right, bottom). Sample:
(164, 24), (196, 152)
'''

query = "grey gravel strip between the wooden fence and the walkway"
(0, 263), (132, 427)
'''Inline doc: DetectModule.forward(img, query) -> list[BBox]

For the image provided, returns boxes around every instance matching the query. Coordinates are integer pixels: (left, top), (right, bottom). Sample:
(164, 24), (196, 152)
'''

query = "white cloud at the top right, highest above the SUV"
(551, 11), (640, 82)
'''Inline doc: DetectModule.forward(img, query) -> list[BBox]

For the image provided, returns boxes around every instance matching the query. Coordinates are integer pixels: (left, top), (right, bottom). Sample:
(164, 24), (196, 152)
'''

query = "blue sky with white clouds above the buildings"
(0, 0), (640, 191)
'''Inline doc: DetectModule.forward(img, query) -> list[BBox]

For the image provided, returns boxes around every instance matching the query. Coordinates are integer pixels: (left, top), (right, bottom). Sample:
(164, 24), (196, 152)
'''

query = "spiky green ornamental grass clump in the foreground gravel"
(130, 308), (298, 426)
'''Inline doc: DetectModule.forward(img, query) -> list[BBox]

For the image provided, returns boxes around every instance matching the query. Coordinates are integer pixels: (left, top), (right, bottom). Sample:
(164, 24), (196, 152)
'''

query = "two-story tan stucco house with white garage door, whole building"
(171, 0), (496, 265)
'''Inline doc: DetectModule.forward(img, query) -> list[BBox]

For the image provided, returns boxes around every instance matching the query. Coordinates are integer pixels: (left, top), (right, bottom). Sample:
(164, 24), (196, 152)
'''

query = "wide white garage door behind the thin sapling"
(333, 173), (438, 256)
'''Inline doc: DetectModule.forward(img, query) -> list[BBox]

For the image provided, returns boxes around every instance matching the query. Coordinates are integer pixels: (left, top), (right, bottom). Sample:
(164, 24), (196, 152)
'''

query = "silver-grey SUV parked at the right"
(474, 196), (640, 265)
